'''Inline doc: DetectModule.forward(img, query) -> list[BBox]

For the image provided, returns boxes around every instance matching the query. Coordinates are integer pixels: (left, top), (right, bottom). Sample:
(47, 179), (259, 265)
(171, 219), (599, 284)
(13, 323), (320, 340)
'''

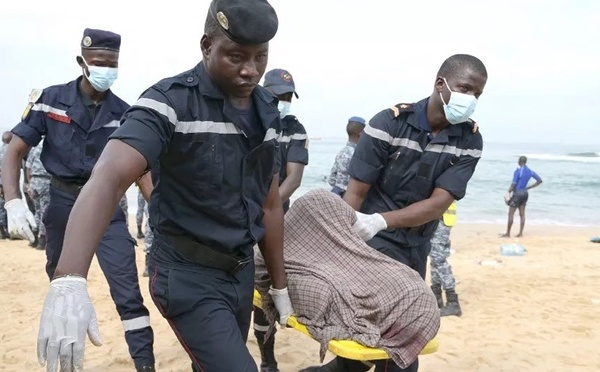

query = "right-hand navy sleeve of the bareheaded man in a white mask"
(435, 132), (483, 200)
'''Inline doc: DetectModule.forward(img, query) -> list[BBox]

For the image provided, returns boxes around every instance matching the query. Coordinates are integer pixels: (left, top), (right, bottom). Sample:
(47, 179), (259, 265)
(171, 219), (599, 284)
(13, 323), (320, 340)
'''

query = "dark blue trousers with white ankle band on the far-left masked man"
(43, 186), (154, 367)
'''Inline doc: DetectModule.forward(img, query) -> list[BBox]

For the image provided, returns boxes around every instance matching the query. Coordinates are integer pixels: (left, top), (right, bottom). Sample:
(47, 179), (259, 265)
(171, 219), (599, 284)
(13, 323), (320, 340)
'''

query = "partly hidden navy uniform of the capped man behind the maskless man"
(279, 115), (308, 212)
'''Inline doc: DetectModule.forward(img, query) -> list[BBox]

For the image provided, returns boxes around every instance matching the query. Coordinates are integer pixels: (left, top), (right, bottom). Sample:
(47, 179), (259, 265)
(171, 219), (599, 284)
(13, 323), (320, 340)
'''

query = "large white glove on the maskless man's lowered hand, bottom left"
(37, 276), (102, 372)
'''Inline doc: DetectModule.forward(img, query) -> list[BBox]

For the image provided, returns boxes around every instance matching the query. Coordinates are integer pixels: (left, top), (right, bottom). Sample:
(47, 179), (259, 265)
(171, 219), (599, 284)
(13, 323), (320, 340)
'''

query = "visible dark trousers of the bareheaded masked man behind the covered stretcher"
(337, 236), (431, 372)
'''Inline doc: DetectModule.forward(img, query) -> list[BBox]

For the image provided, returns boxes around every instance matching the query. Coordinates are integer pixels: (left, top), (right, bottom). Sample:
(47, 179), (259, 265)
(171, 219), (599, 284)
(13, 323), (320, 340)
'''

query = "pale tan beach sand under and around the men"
(0, 221), (600, 372)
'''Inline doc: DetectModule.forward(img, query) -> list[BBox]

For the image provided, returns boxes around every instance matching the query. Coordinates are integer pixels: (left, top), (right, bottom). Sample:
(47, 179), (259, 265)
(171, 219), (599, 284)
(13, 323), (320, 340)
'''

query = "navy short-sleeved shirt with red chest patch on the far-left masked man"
(12, 76), (129, 185)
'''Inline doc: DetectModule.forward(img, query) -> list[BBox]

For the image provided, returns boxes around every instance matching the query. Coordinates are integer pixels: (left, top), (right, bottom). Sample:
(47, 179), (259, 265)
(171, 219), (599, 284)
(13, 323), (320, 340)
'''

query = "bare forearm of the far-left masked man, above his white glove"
(2, 135), (30, 201)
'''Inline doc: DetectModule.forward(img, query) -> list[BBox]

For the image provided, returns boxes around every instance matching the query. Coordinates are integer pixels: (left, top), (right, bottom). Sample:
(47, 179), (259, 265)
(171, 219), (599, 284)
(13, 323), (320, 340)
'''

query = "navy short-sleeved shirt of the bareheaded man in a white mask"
(348, 99), (483, 246)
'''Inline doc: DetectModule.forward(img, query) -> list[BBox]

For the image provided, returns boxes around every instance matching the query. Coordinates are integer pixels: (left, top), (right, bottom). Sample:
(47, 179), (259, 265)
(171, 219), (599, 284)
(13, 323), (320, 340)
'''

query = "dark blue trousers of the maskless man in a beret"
(150, 257), (258, 372)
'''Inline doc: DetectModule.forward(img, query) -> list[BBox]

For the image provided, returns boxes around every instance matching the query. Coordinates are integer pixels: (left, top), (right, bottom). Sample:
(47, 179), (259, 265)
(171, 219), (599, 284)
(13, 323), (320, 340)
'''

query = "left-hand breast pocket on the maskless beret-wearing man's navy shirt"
(174, 133), (223, 191)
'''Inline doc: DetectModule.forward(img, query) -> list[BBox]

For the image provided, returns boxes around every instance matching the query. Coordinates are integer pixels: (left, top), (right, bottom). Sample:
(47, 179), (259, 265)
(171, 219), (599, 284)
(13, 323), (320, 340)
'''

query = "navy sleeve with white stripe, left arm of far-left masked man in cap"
(11, 91), (48, 147)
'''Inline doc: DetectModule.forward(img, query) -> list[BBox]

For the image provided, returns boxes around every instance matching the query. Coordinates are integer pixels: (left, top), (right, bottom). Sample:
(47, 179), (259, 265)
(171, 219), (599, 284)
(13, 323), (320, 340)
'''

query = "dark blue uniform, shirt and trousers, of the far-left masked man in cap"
(12, 77), (154, 366)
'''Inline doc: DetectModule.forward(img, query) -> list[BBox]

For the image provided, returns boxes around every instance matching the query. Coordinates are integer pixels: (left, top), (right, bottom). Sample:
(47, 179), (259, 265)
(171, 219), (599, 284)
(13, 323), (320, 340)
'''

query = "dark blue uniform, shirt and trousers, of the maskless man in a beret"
(112, 62), (281, 371)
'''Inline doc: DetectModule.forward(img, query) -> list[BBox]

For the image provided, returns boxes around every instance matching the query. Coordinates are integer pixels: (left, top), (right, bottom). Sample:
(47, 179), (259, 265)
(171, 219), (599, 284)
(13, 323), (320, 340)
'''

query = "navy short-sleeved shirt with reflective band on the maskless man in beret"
(111, 62), (281, 261)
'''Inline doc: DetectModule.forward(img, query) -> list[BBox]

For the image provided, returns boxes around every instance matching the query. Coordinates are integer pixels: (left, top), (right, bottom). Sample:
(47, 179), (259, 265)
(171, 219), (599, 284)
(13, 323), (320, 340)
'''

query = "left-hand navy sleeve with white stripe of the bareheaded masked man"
(348, 109), (394, 185)
